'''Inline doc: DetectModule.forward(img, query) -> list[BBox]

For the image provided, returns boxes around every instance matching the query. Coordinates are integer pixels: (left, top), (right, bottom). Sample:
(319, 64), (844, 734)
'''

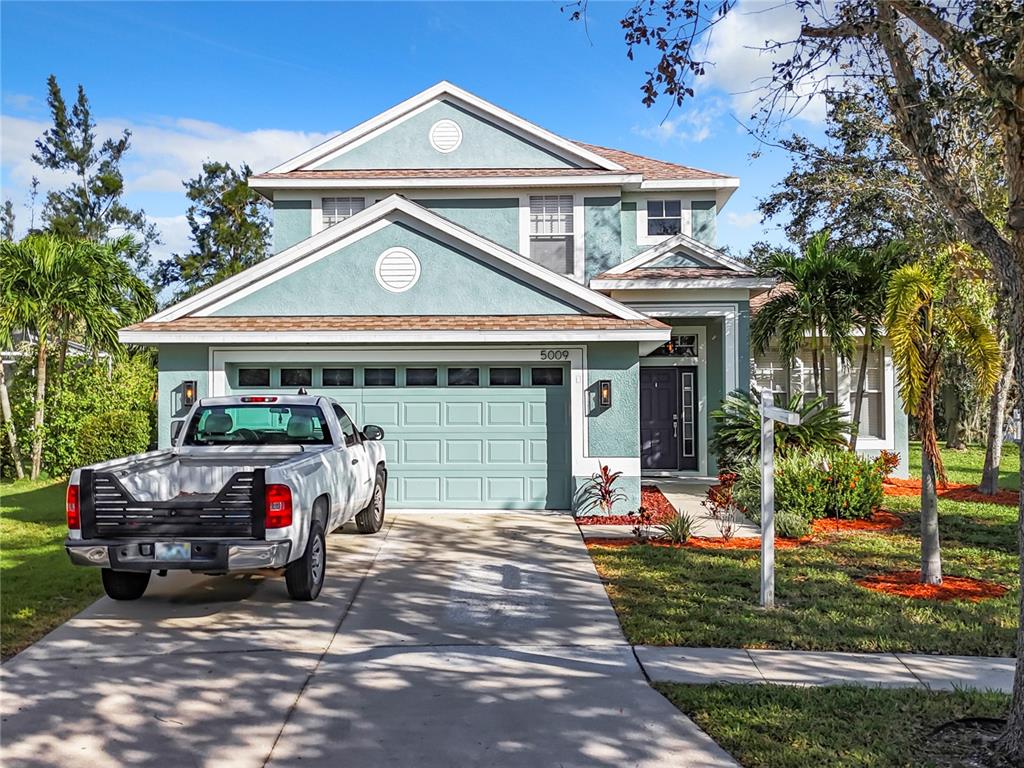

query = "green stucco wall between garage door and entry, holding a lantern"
(573, 342), (640, 514)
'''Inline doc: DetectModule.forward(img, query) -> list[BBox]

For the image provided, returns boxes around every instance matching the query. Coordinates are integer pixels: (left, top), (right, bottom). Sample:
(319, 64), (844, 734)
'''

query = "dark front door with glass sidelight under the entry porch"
(640, 366), (699, 471)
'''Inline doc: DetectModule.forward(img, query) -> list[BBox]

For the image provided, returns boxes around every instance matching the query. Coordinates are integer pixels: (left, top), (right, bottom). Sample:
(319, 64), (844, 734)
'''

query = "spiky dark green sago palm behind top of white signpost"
(709, 389), (850, 471)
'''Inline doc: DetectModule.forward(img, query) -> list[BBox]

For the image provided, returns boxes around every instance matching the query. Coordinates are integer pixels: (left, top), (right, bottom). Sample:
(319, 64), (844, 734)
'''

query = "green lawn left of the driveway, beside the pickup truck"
(0, 480), (102, 658)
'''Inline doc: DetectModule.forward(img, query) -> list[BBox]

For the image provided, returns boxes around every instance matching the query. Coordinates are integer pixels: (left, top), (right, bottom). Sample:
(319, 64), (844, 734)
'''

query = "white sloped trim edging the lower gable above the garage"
(145, 195), (646, 324)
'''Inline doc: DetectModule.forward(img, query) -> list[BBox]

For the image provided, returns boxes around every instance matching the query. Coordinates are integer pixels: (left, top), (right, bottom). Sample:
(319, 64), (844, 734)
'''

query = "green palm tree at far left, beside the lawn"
(0, 233), (154, 479)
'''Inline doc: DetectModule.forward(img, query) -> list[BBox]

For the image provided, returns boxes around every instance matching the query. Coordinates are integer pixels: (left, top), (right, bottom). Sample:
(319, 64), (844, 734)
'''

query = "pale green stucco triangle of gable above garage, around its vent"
(215, 224), (580, 316)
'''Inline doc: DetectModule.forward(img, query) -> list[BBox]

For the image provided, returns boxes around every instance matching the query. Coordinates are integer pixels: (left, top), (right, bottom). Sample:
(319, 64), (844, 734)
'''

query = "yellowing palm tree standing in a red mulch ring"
(886, 264), (999, 584)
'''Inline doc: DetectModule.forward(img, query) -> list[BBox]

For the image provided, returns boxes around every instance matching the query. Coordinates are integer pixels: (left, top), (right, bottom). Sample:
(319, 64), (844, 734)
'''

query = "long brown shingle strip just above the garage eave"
(122, 314), (668, 334)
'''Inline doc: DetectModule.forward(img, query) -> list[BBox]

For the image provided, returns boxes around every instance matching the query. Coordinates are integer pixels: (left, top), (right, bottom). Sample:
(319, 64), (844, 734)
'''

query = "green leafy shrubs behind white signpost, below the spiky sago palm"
(732, 451), (883, 537)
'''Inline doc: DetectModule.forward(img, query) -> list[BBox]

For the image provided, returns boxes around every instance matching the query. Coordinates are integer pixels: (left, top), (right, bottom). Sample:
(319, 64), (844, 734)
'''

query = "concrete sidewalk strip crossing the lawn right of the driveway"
(635, 645), (1016, 693)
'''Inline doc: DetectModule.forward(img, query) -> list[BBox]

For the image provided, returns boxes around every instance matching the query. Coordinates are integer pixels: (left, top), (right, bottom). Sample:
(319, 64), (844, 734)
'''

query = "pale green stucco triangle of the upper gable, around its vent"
(315, 101), (575, 170)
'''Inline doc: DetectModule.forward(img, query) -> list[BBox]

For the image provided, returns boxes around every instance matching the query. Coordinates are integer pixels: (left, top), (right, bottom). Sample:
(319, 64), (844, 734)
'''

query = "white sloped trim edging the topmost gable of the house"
(269, 80), (625, 173)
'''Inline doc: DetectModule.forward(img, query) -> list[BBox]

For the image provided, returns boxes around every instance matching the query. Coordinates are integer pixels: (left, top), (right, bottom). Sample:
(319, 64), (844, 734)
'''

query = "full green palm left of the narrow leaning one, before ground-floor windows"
(751, 231), (856, 397)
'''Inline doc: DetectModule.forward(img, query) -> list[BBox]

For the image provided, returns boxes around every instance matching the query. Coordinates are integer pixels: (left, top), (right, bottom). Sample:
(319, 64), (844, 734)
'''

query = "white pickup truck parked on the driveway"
(65, 394), (387, 600)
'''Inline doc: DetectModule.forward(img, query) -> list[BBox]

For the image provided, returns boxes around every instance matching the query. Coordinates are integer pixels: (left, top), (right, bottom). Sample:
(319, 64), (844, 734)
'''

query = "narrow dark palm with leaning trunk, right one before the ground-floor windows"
(850, 242), (907, 451)
